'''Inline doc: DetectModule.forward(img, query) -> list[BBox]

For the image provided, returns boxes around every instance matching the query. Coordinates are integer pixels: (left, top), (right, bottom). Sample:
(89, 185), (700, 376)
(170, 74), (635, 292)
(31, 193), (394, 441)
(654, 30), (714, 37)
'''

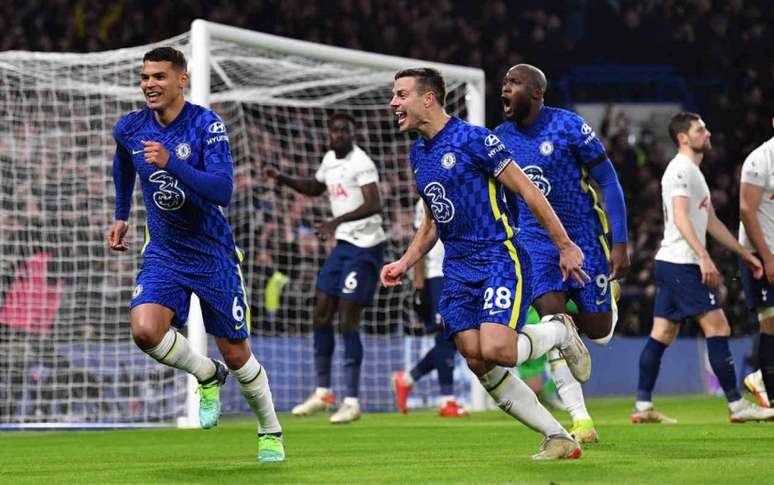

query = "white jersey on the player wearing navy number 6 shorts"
(314, 145), (385, 248)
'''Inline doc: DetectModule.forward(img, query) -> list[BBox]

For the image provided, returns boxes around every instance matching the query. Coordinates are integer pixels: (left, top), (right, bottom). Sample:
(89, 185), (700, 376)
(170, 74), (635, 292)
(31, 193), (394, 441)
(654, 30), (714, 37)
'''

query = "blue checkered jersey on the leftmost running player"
(113, 102), (238, 273)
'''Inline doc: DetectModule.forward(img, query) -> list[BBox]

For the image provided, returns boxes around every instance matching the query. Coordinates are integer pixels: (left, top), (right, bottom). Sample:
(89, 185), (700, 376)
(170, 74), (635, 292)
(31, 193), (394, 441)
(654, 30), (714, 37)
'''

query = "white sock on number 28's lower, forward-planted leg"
(478, 366), (567, 437)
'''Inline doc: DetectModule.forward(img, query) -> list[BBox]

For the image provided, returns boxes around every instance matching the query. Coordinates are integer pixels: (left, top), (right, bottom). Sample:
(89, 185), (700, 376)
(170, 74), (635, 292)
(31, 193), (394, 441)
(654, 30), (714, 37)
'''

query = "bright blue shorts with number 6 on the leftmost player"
(129, 260), (250, 340)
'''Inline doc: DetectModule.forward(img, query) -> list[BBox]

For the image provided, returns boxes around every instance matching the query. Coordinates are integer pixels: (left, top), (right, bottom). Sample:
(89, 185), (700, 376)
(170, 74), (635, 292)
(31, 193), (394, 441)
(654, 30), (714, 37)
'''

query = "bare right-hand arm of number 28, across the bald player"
(497, 162), (590, 285)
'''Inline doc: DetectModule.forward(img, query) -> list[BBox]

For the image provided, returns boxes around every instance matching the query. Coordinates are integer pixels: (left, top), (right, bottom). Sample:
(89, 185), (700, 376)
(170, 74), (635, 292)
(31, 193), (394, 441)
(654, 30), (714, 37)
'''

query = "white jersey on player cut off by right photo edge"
(739, 134), (774, 251)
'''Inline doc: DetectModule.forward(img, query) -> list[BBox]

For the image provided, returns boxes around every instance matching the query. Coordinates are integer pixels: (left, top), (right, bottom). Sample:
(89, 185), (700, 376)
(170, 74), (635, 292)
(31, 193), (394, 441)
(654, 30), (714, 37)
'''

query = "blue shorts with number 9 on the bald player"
(519, 235), (612, 313)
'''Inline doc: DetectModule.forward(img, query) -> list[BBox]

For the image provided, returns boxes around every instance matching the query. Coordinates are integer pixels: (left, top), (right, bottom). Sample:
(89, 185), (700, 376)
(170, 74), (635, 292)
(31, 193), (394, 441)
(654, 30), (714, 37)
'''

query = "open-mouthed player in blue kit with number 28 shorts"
(381, 68), (591, 459)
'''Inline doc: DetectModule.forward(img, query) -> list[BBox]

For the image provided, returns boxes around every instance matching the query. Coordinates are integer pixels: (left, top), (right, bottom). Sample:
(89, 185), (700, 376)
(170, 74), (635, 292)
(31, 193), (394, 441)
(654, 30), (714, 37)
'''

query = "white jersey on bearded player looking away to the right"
(656, 153), (710, 264)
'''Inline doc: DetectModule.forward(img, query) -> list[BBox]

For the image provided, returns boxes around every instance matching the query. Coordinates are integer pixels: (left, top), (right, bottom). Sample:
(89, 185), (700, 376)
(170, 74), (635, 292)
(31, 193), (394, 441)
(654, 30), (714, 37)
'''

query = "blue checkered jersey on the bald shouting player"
(495, 106), (608, 244)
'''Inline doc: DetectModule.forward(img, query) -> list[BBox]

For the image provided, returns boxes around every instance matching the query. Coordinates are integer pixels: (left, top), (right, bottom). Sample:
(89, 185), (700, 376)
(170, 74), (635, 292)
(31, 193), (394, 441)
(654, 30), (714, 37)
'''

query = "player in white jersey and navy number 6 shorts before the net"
(265, 113), (385, 423)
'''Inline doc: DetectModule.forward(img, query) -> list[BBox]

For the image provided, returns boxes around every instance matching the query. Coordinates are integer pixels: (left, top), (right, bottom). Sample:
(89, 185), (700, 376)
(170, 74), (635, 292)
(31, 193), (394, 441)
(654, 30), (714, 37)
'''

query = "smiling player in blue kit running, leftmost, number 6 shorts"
(107, 47), (285, 462)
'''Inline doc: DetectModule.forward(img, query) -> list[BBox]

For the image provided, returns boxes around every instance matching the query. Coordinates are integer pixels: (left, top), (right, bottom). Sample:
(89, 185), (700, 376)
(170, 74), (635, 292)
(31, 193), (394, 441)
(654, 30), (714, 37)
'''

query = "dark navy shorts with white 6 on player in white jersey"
(317, 240), (384, 305)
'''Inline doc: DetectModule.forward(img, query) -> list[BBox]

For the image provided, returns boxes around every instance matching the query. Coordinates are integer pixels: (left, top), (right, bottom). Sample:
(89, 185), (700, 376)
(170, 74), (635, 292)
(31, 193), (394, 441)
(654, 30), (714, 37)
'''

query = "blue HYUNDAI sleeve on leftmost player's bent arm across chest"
(165, 114), (234, 207)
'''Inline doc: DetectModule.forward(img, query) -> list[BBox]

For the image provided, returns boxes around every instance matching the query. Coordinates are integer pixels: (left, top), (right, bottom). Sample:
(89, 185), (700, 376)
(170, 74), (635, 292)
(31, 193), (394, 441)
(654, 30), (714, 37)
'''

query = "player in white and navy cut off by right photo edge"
(739, 119), (774, 407)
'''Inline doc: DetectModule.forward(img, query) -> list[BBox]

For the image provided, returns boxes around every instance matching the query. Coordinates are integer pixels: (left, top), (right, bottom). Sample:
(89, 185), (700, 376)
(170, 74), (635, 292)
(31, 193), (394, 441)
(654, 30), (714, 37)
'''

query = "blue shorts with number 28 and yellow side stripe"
(439, 241), (532, 338)
